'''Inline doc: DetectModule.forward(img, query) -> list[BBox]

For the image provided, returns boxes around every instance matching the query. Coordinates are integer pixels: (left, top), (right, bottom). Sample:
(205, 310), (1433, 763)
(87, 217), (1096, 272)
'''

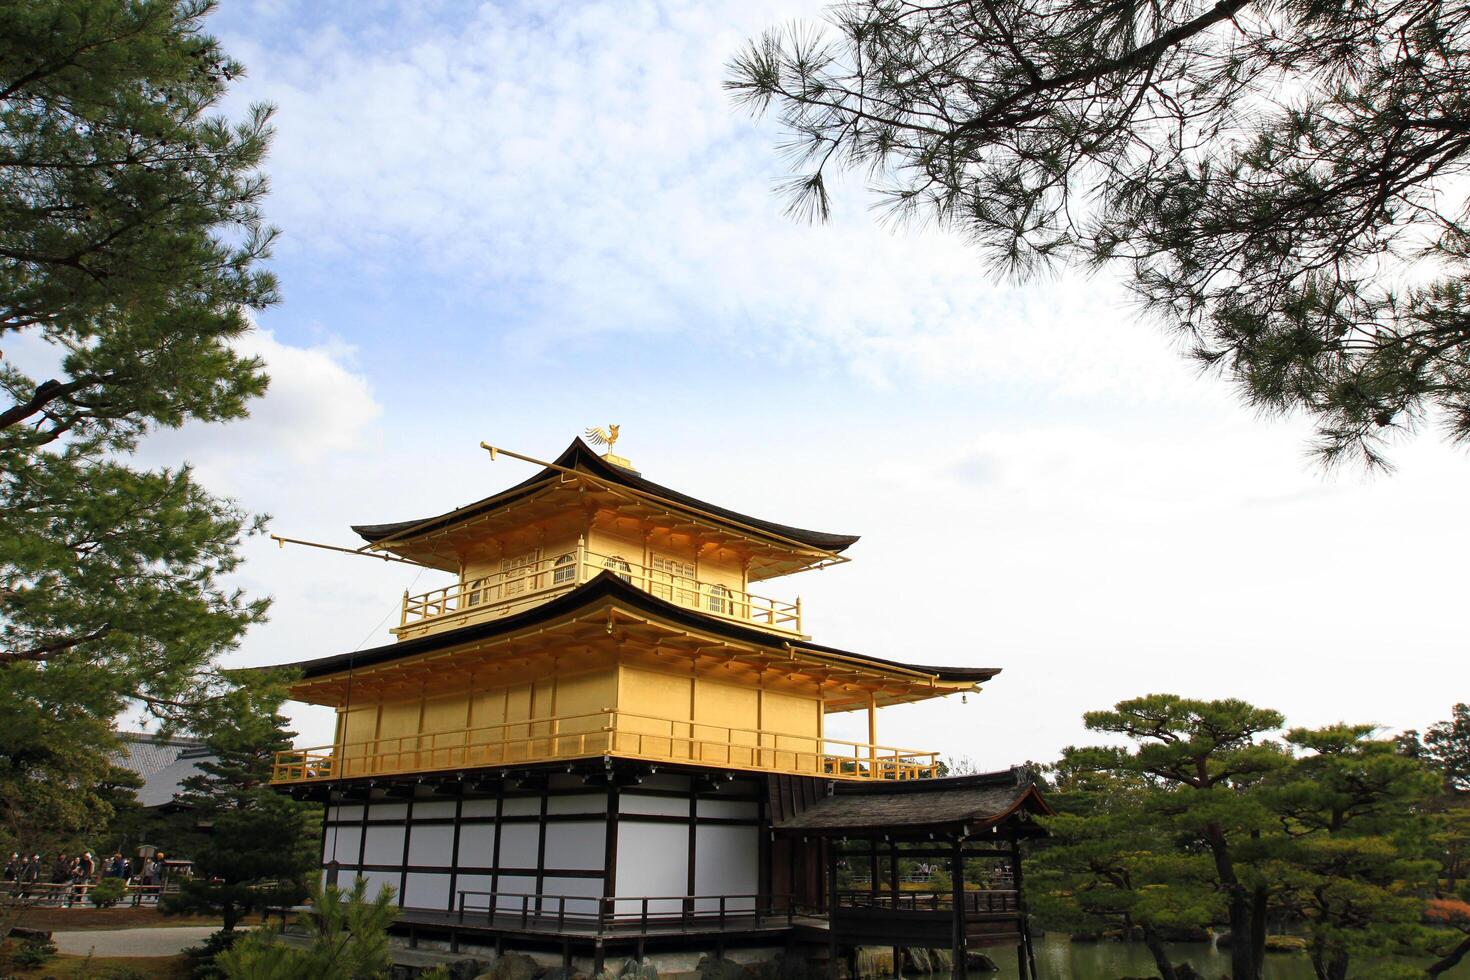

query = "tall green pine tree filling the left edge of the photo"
(0, 0), (276, 833)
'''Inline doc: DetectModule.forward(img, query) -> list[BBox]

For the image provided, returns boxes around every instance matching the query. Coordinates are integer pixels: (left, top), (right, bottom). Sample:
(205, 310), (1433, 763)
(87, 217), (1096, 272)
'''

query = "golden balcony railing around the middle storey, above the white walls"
(270, 710), (939, 783)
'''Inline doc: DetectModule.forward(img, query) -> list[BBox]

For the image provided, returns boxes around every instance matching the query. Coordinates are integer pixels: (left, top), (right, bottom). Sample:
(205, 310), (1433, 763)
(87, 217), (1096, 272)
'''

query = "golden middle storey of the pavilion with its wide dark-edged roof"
(273, 572), (1000, 783)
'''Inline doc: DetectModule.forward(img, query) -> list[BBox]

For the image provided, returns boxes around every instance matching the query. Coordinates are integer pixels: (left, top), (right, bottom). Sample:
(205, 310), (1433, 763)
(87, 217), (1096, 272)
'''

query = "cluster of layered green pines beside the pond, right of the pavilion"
(1030, 695), (1463, 980)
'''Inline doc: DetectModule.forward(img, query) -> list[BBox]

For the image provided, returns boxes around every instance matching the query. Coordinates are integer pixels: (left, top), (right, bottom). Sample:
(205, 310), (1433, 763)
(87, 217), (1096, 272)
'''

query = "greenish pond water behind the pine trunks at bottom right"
(970, 933), (1470, 980)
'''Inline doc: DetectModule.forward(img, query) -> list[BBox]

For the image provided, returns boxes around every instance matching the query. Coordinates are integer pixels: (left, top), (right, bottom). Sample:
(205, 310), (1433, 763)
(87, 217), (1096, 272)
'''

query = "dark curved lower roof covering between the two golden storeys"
(268, 572), (1001, 683)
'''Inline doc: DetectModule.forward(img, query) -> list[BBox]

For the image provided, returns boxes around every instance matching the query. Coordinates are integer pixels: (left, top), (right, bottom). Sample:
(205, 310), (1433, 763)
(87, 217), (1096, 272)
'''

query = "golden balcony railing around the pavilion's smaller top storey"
(394, 547), (801, 636)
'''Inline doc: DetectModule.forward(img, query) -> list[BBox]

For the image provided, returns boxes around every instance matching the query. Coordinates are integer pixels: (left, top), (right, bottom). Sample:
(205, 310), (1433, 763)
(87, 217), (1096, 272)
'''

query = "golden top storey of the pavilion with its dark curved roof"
(353, 439), (857, 639)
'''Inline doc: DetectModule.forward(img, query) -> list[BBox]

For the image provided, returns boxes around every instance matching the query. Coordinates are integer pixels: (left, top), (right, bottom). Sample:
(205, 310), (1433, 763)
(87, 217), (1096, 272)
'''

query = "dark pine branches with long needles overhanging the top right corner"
(726, 0), (1470, 466)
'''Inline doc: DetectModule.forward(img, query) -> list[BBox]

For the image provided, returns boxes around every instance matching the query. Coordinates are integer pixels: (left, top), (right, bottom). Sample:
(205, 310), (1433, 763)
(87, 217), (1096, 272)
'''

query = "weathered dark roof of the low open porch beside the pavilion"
(776, 768), (1051, 835)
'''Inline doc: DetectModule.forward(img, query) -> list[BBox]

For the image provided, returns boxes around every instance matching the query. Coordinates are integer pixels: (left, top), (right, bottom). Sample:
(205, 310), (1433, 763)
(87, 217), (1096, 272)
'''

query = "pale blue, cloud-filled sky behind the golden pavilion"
(129, 0), (1470, 765)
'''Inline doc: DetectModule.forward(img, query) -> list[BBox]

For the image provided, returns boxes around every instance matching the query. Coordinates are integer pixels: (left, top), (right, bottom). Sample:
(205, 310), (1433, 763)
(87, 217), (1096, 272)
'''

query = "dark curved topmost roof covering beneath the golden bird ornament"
(353, 439), (858, 552)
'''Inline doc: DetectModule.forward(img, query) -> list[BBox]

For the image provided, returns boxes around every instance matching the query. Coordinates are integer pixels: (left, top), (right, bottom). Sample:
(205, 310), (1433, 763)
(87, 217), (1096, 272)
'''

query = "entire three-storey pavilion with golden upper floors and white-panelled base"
(264, 433), (1050, 976)
